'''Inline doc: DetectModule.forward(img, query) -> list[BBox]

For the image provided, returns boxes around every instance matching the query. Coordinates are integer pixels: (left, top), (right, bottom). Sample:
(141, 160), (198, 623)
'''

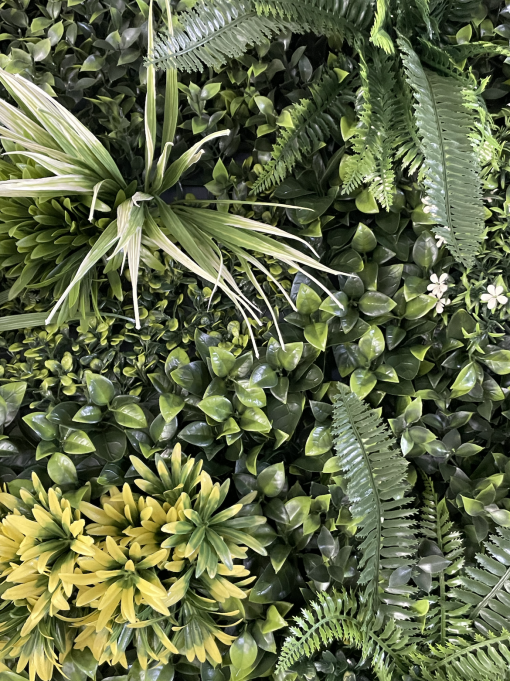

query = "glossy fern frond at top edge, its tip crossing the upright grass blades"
(148, 0), (296, 71)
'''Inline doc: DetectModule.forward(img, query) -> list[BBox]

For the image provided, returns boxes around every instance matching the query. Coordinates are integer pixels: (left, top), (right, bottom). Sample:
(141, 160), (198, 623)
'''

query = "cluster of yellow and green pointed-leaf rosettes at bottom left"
(0, 446), (266, 681)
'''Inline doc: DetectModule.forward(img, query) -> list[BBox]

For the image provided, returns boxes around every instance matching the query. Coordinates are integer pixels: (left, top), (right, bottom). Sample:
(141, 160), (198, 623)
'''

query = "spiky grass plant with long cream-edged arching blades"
(0, 4), (342, 342)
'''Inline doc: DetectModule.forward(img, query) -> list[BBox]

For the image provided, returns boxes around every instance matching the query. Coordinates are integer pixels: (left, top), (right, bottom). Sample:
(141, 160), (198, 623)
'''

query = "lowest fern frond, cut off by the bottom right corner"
(417, 631), (510, 681)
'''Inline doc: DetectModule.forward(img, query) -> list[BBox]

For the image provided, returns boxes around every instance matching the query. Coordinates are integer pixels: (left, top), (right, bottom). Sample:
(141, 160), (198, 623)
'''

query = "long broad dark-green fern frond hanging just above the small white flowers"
(399, 38), (484, 266)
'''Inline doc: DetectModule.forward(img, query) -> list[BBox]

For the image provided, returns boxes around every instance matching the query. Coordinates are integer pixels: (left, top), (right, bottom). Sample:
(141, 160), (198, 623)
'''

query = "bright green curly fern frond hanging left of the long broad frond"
(343, 51), (397, 210)
